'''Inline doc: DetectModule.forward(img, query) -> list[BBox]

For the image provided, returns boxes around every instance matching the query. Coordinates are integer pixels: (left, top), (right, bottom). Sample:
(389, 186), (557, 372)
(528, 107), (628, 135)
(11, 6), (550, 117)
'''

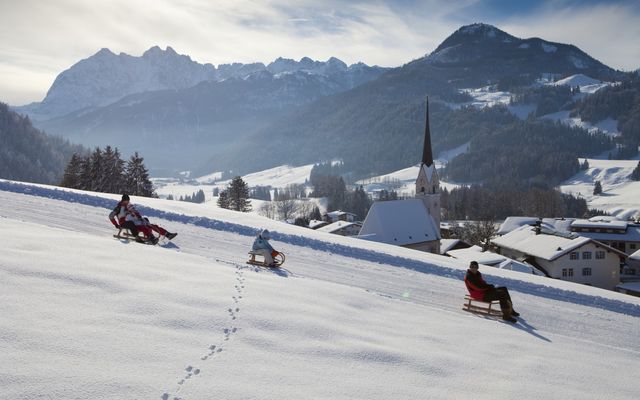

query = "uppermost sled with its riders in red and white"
(109, 194), (177, 244)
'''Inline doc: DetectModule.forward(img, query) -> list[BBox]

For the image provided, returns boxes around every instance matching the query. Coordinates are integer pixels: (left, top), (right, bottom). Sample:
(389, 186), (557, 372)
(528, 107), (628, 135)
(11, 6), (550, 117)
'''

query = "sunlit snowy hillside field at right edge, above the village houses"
(560, 158), (640, 219)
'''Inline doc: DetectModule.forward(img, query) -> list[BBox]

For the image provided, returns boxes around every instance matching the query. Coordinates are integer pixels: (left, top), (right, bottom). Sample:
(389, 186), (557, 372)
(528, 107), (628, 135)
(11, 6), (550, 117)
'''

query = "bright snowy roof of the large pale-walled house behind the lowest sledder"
(492, 226), (604, 261)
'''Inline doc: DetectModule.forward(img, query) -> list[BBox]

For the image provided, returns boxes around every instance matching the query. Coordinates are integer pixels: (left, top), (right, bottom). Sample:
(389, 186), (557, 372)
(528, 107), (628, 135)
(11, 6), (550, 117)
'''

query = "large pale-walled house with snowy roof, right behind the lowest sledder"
(491, 225), (626, 290)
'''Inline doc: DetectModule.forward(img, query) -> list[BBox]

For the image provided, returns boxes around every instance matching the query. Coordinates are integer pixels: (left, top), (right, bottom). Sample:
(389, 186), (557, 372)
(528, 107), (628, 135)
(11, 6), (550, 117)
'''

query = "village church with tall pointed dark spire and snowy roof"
(358, 99), (441, 254)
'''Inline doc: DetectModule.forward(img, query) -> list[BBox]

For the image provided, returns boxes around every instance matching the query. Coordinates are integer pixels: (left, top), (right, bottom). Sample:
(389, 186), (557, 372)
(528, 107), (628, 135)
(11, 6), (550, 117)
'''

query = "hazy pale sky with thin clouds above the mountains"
(0, 0), (640, 105)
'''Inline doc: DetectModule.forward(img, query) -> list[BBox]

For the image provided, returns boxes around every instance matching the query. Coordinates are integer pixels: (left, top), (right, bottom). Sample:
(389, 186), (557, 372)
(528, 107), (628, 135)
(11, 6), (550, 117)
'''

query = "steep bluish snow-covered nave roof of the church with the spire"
(358, 199), (440, 246)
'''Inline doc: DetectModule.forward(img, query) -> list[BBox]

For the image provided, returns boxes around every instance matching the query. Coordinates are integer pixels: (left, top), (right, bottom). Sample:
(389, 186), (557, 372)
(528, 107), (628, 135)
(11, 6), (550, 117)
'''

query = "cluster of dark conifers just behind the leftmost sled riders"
(60, 146), (156, 197)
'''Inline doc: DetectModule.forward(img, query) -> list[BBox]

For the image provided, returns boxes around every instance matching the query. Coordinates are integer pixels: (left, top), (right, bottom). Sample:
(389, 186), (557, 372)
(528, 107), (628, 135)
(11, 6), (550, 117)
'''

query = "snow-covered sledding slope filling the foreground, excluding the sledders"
(0, 181), (640, 400)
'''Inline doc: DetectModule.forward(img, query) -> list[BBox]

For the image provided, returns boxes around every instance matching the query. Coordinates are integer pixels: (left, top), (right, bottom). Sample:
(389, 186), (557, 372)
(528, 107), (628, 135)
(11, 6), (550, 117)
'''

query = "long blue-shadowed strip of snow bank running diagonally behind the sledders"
(0, 181), (640, 317)
